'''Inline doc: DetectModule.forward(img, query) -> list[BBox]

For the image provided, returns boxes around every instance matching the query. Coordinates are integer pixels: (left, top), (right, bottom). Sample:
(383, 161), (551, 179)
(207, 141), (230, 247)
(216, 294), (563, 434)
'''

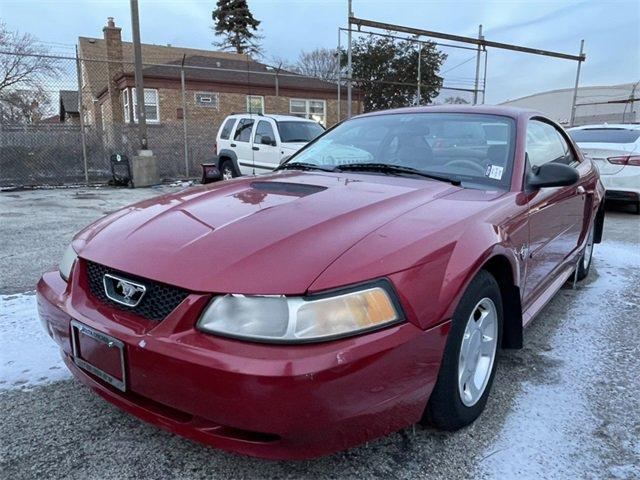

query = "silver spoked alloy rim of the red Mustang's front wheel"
(458, 297), (498, 407)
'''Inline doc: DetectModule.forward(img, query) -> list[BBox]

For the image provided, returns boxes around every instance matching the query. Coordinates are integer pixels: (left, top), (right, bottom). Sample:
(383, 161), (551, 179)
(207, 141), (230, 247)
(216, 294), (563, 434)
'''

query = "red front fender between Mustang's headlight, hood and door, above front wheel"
(309, 190), (529, 329)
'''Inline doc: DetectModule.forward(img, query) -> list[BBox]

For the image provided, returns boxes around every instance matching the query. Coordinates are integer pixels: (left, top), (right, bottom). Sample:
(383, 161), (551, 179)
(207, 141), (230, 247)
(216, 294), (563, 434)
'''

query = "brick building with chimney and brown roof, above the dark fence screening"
(78, 18), (361, 129)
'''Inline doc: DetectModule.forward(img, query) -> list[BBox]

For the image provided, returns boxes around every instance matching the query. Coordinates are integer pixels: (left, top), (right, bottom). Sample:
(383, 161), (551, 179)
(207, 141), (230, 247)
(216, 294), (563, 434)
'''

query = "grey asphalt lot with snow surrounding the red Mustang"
(0, 187), (640, 479)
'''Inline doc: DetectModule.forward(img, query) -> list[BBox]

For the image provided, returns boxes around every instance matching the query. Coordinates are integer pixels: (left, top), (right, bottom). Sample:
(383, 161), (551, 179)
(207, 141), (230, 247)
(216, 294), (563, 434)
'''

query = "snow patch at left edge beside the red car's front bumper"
(0, 292), (71, 390)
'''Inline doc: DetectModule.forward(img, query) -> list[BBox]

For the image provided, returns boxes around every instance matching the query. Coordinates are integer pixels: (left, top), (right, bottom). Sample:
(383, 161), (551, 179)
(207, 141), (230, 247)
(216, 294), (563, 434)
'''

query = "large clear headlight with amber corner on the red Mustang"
(198, 286), (402, 343)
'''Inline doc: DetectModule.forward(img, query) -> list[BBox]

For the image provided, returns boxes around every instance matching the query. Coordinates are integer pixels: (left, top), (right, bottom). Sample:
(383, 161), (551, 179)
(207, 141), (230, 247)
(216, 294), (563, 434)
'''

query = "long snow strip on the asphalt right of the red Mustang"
(478, 242), (640, 478)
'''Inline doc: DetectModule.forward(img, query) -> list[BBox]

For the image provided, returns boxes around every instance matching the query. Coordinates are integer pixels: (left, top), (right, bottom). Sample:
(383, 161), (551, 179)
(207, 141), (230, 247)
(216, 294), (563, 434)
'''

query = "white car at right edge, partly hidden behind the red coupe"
(567, 123), (640, 214)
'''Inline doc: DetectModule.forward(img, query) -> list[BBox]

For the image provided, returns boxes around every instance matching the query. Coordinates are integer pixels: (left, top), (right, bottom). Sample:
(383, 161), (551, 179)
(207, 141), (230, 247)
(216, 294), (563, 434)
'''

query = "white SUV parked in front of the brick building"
(216, 113), (324, 180)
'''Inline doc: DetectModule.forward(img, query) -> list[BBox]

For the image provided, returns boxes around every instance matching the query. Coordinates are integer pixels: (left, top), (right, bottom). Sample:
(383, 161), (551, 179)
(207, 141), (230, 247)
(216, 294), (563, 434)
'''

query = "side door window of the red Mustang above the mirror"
(527, 120), (575, 167)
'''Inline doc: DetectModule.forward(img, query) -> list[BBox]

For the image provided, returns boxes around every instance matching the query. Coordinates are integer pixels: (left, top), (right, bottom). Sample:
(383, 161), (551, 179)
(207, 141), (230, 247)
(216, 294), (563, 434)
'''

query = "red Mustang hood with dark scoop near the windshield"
(74, 172), (458, 294)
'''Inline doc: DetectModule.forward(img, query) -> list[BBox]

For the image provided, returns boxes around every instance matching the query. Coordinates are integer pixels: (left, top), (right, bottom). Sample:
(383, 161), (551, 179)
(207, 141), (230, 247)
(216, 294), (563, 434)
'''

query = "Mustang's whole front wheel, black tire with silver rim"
(423, 270), (503, 431)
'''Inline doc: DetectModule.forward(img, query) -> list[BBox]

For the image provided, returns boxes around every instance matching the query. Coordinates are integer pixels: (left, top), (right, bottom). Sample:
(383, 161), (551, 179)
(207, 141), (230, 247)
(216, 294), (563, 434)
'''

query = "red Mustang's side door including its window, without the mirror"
(523, 119), (585, 303)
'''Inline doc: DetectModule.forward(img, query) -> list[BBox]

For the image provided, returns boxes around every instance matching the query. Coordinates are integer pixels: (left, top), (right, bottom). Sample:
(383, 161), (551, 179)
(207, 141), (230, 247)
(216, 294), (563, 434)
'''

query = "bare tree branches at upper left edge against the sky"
(0, 23), (60, 96)
